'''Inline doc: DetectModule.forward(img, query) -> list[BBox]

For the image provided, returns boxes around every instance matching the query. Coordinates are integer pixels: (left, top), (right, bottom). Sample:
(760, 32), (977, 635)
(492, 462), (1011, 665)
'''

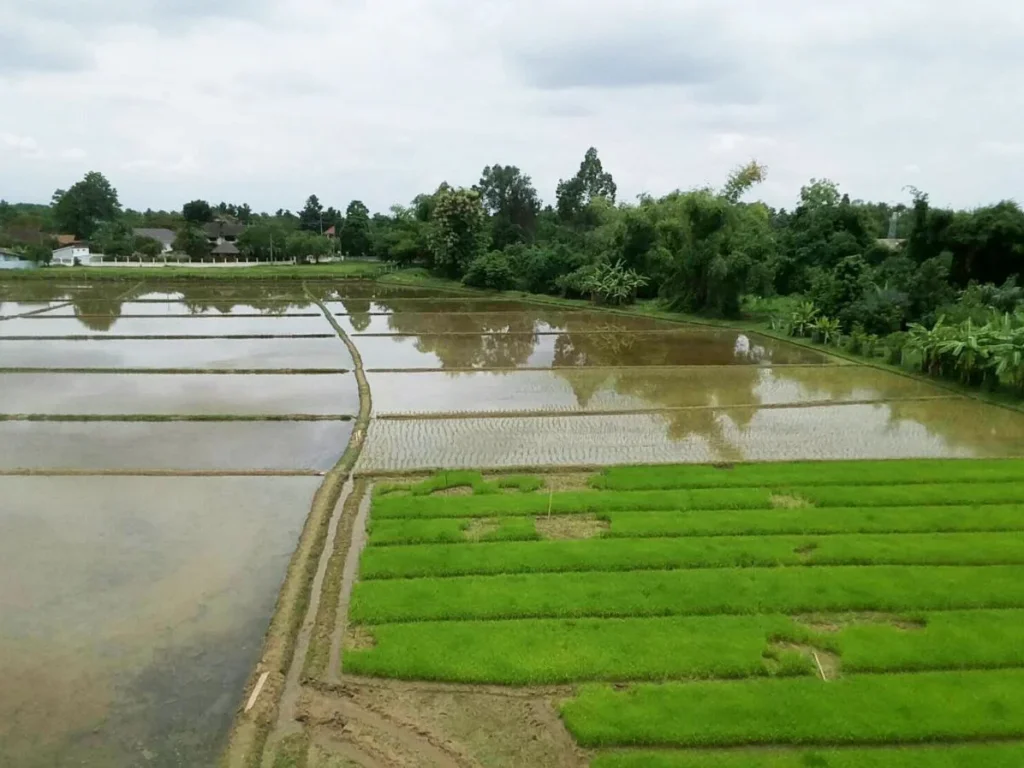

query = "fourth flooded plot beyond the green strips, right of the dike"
(337, 307), (684, 335)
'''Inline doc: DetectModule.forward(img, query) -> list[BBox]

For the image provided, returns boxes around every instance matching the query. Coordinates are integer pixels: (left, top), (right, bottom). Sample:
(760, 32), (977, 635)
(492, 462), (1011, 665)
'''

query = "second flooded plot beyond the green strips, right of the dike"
(368, 366), (949, 415)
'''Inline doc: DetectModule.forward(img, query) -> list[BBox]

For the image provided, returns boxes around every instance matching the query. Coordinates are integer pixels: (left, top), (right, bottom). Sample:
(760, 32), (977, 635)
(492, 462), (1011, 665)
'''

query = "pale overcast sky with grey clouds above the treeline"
(0, 0), (1024, 211)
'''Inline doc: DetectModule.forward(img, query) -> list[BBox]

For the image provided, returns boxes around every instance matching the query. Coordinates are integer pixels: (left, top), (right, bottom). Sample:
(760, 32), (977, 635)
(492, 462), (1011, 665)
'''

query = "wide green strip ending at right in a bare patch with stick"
(344, 615), (814, 685)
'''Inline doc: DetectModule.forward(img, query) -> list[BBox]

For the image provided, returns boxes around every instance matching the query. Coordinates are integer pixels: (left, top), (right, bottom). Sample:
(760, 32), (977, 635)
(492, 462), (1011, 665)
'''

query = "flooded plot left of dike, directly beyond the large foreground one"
(0, 421), (352, 471)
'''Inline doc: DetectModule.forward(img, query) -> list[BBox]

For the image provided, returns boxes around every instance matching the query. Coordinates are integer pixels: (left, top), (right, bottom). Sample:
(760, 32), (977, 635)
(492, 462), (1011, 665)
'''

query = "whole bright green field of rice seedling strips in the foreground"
(343, 460), (1024, 768)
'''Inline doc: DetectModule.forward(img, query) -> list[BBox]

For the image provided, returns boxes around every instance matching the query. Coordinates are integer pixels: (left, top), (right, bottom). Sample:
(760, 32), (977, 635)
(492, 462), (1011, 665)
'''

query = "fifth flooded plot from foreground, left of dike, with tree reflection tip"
(0, 315), (334, 338)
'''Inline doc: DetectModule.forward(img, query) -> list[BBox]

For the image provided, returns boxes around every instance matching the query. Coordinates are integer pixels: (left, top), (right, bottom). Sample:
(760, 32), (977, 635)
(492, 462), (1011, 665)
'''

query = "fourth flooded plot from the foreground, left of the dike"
(0, 337), (352, 371)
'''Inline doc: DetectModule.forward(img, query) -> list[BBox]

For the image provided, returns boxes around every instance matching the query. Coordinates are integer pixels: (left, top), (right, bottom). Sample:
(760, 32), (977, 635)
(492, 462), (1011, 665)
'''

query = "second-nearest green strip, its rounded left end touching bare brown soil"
(561, 670), (1024, 746)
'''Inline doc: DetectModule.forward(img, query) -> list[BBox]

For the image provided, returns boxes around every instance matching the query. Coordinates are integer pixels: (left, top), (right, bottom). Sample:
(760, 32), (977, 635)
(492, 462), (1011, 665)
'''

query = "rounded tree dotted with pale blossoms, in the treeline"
(429, 188), (487, 278)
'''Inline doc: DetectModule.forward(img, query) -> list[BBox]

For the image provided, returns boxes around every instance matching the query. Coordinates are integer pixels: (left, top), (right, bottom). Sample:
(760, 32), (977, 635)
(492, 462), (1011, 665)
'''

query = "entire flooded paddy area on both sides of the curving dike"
(0, 280), (1024, 768)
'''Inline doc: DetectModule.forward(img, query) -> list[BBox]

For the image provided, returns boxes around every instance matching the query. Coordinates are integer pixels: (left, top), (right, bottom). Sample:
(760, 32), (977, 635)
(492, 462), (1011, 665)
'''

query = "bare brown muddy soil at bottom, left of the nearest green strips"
(298, 678), (587, 768)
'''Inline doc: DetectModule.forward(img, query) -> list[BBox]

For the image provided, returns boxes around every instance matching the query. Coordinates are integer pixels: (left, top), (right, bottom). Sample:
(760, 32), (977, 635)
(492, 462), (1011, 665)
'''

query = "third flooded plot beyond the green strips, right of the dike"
(353, 329), (829, 369)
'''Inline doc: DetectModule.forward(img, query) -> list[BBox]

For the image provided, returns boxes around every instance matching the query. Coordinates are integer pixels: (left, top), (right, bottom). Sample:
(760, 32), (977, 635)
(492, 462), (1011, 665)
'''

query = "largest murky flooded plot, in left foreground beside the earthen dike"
(0, 477), (319, 768)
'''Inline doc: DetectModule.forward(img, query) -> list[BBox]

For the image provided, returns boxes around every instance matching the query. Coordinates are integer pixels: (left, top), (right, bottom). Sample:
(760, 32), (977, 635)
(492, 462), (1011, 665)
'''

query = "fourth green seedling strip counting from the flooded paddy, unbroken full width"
(361, 532), (1024, 580)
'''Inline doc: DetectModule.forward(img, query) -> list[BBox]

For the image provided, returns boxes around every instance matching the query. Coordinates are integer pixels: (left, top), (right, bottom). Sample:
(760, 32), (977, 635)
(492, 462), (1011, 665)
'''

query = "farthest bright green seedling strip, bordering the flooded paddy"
(591, 459), (1024, 490)
